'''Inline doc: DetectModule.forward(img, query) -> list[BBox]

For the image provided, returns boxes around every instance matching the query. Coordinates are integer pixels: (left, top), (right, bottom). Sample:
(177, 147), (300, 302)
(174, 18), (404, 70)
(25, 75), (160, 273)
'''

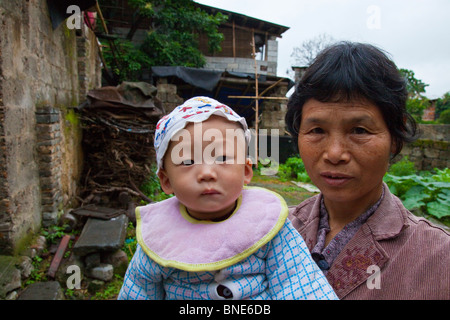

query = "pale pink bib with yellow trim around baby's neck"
(136, 187), (288, 271)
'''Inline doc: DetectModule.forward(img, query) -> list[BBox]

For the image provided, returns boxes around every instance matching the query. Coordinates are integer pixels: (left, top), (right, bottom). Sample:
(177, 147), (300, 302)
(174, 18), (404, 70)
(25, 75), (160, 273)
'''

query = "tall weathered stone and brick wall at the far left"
(0, 0), (101, 254)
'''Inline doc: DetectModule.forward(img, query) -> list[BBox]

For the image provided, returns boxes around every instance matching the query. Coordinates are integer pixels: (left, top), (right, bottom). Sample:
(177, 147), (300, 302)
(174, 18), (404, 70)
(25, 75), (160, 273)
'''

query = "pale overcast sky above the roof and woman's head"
(195, 0), (450, 99)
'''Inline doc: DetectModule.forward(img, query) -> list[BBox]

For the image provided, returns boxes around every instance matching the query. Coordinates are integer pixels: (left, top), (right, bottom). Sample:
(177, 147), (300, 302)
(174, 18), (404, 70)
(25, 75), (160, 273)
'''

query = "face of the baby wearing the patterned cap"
(158, 116), (253, 220)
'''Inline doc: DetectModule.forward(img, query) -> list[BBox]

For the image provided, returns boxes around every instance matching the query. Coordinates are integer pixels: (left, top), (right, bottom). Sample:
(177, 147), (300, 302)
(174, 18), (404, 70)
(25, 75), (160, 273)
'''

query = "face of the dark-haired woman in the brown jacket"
(298, 99), (393, 209)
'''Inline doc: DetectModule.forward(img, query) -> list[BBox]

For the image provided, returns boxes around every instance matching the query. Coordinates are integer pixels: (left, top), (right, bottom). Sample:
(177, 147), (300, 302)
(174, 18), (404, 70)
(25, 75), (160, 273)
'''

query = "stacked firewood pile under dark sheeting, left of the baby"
(80, 81), (164, 204)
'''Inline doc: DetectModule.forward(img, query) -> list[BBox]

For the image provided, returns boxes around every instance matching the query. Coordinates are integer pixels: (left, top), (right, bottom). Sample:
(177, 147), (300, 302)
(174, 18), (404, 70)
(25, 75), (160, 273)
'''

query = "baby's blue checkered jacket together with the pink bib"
(118, 187), (337, 300)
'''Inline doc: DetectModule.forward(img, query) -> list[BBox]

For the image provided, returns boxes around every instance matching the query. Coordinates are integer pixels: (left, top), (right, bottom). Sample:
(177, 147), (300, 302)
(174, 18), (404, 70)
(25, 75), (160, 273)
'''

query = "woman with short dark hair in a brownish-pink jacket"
(286, 42), (450, 299)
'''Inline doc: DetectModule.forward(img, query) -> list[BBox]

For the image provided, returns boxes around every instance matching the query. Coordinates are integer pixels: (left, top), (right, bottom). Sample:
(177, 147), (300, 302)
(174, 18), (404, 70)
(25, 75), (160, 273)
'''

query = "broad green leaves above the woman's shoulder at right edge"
(384, 168), (450, 219)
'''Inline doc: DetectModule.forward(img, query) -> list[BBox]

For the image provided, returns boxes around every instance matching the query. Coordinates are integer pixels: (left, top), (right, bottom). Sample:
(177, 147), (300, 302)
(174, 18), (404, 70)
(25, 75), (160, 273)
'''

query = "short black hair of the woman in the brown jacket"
(285, 42), (417, 156)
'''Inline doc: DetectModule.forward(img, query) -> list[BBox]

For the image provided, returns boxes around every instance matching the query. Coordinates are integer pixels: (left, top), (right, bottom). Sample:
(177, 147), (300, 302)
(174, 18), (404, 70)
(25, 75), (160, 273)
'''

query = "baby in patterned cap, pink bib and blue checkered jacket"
(118, 97), (337, 300)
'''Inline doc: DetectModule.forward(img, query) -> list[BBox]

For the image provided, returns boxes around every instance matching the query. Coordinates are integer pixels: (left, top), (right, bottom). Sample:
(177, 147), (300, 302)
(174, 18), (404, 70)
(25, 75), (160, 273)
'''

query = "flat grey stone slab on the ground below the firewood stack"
(73, 214), (128, 256)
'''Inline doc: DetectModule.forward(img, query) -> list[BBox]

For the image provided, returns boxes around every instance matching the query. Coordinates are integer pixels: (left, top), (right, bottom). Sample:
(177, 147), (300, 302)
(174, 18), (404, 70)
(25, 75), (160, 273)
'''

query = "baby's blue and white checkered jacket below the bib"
(118, 220), (337, 300)
